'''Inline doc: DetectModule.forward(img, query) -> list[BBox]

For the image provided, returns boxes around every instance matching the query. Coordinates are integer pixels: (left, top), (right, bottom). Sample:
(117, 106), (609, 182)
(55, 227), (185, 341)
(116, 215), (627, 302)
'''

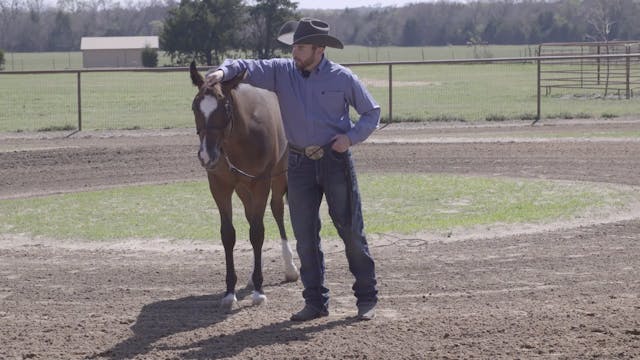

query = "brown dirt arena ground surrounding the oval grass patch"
(0, 120), (640, 359)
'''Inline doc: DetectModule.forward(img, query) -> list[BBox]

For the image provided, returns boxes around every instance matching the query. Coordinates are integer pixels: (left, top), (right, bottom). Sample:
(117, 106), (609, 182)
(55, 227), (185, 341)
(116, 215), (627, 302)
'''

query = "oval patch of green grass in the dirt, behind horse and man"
(0, 174), (640, 241)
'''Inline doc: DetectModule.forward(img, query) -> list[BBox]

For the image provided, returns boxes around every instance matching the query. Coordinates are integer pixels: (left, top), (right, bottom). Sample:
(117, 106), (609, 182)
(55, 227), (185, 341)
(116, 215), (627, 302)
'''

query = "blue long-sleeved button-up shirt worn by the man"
(218, 57), (380, 147)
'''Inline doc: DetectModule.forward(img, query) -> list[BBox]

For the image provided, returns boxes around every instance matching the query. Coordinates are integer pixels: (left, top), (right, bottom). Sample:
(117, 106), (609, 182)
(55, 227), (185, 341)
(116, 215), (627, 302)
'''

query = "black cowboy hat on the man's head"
(278, 18), (344, 49)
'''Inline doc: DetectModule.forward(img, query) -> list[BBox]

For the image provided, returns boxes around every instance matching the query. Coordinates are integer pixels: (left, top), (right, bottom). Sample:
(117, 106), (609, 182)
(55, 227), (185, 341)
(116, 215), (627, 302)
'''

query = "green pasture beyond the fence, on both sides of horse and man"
(0, 46), (640, 132)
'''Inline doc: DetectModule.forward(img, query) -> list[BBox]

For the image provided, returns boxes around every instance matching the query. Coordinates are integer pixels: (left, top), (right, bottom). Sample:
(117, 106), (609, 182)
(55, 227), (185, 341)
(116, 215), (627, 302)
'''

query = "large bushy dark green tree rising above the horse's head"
(160, 0), (244, 66)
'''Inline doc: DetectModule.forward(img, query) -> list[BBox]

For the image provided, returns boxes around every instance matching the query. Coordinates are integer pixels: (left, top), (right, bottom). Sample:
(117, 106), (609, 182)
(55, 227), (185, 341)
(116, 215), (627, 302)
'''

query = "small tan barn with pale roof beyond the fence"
(80, 36), (158, 68)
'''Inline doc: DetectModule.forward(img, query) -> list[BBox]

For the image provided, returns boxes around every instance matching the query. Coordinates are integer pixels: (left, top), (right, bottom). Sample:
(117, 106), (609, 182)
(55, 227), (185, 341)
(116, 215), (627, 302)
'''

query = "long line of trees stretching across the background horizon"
(0, 0), (640, 59)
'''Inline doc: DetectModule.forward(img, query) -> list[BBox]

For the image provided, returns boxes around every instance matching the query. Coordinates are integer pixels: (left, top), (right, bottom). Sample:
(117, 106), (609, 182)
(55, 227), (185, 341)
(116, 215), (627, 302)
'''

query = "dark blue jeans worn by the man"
(288, 149), (378, 310)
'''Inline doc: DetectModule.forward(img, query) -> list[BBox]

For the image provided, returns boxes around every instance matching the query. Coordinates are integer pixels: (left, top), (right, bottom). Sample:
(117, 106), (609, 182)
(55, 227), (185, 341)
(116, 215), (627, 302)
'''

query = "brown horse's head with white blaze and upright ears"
(189, 61), (245, 170)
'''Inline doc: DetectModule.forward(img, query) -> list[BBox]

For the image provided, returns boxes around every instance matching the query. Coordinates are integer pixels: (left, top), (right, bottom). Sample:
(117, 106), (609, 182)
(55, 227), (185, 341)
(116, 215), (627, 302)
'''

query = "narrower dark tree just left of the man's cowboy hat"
(246, 0), (298, 59)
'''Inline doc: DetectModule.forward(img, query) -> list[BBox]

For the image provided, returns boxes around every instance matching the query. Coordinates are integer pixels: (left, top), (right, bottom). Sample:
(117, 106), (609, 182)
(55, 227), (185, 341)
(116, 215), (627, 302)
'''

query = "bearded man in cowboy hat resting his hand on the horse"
(206, 18), (380, 321)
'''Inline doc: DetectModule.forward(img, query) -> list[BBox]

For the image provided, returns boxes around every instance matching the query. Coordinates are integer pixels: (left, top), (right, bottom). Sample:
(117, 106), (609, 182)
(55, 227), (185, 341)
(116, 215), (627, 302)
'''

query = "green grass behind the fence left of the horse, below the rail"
(0, 71), (195, 132)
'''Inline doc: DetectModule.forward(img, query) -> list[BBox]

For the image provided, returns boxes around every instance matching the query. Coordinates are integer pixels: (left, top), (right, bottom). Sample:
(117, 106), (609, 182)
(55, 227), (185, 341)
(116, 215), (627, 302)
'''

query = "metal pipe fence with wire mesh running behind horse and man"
(0, 53), (640, 132)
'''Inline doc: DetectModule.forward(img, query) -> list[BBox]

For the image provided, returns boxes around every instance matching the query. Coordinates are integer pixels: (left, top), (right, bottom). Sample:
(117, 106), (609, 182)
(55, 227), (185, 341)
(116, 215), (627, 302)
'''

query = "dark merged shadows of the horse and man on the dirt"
(91, 288), (355, 360)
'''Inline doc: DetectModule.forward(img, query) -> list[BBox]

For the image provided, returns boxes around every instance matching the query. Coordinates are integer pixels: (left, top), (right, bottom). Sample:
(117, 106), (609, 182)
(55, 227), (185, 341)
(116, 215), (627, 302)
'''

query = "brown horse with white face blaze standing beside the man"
(190, 62), (298, 309)
